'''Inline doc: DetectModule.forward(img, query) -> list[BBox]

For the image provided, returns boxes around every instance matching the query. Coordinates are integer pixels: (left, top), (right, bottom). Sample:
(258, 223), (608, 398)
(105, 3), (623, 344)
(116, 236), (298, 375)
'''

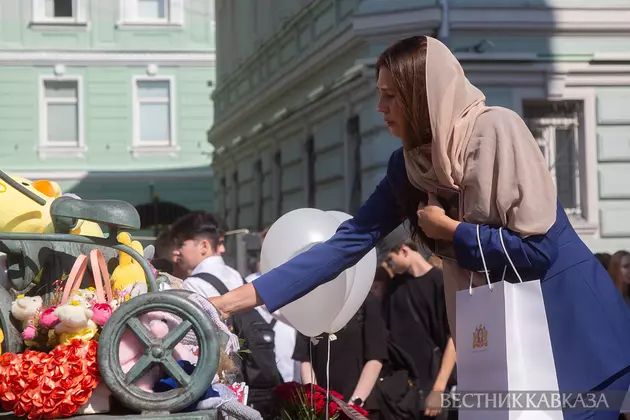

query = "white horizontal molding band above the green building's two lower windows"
(0, 50), (216, 67)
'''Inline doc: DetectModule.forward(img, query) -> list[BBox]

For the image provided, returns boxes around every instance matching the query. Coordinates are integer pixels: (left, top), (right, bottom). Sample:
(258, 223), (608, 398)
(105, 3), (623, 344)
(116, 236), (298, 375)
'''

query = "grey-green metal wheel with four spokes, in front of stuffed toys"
(98, 292), (219, 412)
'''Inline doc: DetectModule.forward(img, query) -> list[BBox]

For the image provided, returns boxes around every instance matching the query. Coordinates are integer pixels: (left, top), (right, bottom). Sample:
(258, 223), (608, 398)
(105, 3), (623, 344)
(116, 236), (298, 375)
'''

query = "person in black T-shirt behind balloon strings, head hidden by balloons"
(293, 294), (387, 419)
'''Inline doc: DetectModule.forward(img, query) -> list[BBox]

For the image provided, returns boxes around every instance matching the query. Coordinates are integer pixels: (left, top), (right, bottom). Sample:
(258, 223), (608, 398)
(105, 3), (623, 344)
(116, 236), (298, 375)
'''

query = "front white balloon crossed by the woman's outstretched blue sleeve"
(260, 208), (346, 337)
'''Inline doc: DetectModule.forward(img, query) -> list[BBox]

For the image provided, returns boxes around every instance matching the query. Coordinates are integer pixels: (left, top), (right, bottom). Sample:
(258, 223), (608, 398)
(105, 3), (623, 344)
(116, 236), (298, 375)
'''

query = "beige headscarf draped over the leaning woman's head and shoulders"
(404, 37), (556, 337)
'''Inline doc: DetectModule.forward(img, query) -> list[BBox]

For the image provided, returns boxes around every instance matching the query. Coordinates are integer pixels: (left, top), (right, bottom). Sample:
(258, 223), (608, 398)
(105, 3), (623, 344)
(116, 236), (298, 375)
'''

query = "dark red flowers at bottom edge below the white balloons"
(274, 382), (368, 420)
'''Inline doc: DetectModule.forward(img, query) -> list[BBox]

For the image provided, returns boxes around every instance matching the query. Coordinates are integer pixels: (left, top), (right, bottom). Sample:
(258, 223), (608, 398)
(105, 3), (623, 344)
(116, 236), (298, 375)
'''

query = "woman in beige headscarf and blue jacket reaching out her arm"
(212, 36), (630, 419)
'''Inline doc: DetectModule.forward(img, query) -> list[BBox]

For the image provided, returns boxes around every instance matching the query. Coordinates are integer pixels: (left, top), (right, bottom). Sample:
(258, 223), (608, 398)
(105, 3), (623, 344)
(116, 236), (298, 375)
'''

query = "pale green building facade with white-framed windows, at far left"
(0, 0), (215, 236)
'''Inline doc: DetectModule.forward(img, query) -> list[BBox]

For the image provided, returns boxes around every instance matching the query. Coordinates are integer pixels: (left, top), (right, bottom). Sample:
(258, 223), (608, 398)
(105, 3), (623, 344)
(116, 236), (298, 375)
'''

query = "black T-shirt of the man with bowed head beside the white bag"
(383, 268), (450, 387)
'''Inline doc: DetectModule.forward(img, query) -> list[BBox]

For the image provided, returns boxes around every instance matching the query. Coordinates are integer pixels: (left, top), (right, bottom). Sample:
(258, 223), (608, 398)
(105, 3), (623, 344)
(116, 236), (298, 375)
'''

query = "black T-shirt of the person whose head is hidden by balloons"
(293, 294), (387, 401)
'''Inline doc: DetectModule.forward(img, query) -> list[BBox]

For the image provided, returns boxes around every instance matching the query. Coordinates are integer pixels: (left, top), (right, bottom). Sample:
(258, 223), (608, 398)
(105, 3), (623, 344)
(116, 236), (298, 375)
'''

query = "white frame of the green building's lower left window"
(38, 75), (87, 156)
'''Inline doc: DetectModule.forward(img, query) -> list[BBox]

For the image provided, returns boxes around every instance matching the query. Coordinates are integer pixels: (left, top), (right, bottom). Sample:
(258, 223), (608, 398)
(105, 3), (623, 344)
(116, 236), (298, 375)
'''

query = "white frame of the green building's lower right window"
(132, 75), (177, 151)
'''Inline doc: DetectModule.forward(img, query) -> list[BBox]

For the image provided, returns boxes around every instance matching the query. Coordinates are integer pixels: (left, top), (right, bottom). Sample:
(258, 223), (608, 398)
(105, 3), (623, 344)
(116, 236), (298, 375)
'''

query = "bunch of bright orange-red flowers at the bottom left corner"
(0, 340), (100, 419)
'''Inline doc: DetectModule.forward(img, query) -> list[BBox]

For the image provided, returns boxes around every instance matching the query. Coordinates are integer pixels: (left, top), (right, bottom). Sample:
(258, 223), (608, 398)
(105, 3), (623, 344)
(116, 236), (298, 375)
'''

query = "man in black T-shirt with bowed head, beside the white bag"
(379, 225), (455, 418)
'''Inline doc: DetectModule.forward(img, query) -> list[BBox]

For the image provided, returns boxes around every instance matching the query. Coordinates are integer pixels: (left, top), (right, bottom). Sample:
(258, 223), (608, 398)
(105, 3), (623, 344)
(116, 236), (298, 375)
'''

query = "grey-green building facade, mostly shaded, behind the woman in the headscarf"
(208, 0), (630, 252)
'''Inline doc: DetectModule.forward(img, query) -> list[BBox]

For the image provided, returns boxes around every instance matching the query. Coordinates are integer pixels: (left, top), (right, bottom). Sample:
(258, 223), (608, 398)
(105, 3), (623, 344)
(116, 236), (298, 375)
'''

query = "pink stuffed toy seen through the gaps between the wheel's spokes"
(119, 311), (196, 392)
